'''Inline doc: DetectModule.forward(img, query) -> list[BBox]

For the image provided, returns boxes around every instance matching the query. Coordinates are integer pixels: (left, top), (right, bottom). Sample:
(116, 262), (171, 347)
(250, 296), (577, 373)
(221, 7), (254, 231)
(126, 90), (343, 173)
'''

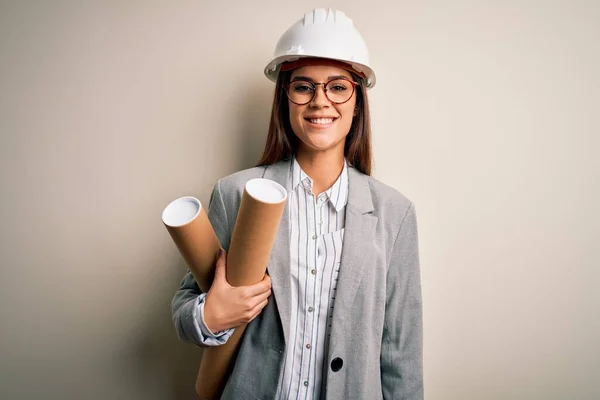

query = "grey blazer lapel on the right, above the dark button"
(329, 168), (378, 354)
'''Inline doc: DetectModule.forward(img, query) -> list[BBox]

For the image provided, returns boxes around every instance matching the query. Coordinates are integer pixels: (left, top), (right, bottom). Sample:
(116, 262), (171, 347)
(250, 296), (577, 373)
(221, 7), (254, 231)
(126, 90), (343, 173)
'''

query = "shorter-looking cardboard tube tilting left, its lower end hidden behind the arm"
(162, 196), (221, 293)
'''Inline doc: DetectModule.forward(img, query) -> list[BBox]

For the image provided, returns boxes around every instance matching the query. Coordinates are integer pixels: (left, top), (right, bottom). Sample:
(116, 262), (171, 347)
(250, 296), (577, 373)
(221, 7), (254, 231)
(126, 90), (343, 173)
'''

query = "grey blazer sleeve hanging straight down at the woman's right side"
(380, 204), (424, 399)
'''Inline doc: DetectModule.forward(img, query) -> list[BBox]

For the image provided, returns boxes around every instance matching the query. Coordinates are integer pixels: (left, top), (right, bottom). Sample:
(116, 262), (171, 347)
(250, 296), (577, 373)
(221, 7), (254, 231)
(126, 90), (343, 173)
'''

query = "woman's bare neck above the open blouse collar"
(296, 149), (344, 195)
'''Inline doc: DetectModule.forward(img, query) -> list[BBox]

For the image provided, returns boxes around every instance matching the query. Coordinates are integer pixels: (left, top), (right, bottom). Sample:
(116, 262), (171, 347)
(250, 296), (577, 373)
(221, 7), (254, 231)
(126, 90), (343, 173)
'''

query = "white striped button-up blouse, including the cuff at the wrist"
(194, 158), (348, 400)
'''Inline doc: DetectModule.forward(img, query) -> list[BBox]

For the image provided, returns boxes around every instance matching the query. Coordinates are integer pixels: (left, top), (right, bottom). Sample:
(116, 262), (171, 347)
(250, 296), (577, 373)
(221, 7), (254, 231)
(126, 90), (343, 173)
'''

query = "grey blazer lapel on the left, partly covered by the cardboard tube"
(263, 161), (291, 343)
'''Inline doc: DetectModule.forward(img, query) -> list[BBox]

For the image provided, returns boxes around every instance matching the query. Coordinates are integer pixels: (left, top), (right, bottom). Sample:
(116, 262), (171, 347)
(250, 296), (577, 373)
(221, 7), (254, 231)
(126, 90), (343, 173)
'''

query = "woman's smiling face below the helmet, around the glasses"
(288, 66), (356, 154)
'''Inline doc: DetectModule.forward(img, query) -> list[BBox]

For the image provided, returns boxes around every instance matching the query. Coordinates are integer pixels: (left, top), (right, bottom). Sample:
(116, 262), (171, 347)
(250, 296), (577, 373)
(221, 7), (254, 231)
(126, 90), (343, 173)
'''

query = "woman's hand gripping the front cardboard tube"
(204, 249), (271, 333)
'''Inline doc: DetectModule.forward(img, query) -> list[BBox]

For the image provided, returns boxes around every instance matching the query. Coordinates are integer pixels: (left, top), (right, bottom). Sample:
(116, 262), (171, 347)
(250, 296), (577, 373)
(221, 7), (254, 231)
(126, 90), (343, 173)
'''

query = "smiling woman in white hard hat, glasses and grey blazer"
(172, 9), (423, 400)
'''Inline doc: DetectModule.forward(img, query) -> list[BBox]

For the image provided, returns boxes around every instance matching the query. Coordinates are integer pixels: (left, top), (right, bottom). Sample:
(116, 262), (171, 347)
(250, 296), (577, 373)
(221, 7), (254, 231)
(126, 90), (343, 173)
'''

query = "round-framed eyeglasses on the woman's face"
(283, 78), (358, 106)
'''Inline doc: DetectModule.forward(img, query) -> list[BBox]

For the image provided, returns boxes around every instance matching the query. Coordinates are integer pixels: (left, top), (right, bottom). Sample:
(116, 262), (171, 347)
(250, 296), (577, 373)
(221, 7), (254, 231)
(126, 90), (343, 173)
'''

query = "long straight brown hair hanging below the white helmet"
(257, 71), (373, 175)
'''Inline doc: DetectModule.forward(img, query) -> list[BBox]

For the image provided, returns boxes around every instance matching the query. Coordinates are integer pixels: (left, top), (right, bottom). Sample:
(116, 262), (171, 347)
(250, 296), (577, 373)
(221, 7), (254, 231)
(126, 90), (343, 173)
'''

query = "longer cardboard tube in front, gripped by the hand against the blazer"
(196, 179), (287, 400)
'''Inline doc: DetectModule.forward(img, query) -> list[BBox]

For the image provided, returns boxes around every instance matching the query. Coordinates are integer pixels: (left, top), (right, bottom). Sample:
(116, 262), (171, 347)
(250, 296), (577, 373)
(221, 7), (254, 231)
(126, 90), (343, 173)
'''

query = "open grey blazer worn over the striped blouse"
(172, 161), (423, 400)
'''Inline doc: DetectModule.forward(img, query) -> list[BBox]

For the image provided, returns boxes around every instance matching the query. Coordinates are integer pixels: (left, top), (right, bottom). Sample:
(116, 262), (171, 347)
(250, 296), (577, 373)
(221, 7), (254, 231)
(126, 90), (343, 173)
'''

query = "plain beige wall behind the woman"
(0, 0), (600, 400)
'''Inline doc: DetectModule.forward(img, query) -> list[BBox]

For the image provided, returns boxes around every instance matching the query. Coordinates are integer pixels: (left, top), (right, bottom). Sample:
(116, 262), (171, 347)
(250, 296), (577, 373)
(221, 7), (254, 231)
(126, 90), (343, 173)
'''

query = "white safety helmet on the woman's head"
(265, 8), (375, 89)
